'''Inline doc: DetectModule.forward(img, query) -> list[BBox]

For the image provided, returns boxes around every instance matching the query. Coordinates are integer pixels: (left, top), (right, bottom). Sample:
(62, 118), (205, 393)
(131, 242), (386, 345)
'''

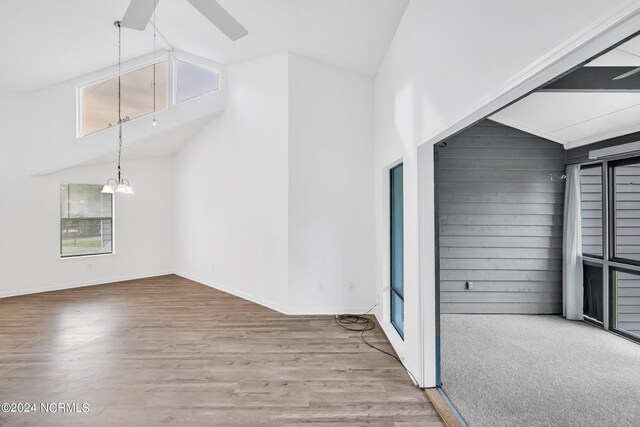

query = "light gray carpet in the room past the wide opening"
(441, 314), (640, 427)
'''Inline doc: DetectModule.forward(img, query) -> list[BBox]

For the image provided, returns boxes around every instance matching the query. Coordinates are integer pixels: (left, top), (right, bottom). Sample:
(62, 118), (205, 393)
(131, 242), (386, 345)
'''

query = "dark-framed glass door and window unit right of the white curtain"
(580, 157), (640, 341)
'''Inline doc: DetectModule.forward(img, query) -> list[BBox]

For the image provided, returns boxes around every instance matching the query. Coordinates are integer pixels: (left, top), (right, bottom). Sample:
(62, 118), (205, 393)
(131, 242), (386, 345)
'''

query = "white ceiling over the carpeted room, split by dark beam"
(491, 37), (640, 148)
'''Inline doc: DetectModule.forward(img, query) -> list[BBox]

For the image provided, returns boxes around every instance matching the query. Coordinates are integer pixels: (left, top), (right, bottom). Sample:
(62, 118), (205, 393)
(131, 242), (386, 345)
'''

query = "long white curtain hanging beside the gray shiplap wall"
(562, 165), (584, 320)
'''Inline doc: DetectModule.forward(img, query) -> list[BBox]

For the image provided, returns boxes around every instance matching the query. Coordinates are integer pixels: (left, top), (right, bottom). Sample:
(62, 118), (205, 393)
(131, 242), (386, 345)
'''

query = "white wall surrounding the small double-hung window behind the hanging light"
(0, 94), (173, 296)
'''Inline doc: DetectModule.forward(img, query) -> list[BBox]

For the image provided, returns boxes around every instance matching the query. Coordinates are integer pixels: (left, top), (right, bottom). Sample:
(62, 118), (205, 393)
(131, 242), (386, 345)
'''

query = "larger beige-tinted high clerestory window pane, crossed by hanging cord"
(80, 61), (167, 136)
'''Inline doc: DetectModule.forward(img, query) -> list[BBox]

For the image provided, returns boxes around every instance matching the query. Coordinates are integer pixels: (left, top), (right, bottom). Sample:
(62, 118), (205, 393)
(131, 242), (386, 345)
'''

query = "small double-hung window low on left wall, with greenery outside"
(60, 184), (113, 257)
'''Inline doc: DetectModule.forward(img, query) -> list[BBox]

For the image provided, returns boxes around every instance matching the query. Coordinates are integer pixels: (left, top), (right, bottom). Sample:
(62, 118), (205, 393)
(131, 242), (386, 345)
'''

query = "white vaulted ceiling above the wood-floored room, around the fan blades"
(0, 0), (408, 92)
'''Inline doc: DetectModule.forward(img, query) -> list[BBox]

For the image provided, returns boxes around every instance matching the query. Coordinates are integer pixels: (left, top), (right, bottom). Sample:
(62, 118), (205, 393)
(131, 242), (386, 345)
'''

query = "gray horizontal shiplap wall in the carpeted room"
(437, 120), (564, 313)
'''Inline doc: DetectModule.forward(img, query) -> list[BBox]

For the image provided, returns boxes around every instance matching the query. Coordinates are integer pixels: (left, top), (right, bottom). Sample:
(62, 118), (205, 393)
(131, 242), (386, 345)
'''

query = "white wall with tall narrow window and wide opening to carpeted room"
(375, 0), (639, 386)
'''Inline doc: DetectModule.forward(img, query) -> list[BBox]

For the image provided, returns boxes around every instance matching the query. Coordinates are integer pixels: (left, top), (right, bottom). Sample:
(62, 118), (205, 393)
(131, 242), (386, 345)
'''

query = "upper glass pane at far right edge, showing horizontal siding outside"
(614, 160), (640, 261)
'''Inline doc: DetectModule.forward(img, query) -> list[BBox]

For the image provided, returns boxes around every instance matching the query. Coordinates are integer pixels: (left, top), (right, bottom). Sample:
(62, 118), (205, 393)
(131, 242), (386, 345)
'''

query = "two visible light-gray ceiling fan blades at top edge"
(121, 0), (249, 41)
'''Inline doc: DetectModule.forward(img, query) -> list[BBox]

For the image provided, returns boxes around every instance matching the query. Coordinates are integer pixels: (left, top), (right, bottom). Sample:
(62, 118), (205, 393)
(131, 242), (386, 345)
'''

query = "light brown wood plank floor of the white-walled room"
(0, 276), (444, 426)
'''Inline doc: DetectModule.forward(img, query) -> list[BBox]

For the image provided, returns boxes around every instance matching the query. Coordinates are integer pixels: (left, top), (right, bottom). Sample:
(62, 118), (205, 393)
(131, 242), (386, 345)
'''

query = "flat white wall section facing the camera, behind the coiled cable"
(289, 54), (375, 313)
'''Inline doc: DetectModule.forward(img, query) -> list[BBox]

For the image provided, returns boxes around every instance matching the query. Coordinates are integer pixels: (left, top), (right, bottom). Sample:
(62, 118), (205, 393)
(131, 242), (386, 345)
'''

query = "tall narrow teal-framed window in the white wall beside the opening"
(389, 164), (404, 338)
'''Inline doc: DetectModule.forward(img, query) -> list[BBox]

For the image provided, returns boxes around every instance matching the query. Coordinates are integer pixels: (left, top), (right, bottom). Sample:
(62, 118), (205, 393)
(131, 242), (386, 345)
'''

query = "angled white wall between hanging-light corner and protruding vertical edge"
(175, 54), (288, 310)
